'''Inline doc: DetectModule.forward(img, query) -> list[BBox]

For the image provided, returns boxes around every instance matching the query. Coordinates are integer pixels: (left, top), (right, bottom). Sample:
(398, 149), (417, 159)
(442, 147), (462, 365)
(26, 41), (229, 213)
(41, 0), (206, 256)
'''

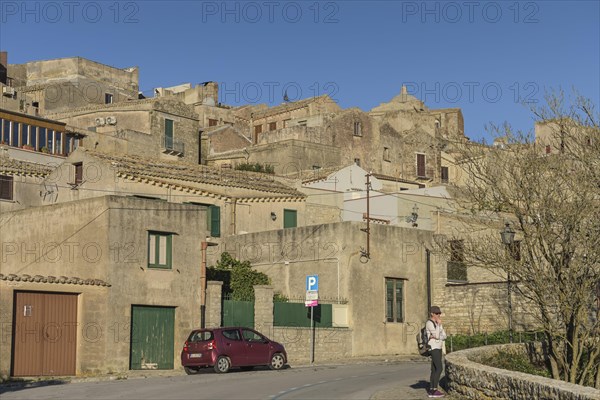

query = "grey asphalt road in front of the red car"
(0, 361), (436, 400)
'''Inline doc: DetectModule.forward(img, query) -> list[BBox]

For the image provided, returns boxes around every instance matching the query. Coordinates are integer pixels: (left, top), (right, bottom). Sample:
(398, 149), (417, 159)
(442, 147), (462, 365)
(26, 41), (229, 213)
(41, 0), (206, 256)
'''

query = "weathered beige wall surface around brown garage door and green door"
(0, 196), (207, 375)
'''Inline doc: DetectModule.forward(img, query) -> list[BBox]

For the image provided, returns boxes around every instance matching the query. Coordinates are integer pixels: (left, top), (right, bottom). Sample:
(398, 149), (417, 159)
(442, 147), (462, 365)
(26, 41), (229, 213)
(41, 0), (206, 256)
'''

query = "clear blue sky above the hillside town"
(0, 0), (600, 140)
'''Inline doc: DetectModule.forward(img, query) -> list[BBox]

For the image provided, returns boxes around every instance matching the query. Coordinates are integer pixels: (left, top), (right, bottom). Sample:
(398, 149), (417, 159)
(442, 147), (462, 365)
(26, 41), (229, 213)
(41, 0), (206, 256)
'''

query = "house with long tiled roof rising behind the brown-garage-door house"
(43, 147), (307, 238)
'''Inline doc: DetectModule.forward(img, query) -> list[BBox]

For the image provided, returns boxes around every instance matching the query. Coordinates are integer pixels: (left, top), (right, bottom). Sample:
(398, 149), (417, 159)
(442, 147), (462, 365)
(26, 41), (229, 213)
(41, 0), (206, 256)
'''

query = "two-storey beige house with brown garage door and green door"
(0, 195), (209, 376)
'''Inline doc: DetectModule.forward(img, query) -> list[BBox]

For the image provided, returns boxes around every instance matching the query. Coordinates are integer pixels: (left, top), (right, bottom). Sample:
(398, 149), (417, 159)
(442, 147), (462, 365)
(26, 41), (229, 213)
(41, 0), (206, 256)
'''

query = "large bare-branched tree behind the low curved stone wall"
(456, 91), (600, 388)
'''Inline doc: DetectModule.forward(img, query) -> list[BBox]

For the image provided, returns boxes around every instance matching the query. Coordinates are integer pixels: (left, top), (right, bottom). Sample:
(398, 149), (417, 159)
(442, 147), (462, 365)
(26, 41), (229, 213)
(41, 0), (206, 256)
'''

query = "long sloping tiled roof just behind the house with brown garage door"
(86, 150), (305, 198)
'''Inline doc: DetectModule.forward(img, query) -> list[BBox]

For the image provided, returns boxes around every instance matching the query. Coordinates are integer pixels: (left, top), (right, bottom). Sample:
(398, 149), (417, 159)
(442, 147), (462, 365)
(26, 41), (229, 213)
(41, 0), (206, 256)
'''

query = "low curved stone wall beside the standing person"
(446, 344), (600, 400)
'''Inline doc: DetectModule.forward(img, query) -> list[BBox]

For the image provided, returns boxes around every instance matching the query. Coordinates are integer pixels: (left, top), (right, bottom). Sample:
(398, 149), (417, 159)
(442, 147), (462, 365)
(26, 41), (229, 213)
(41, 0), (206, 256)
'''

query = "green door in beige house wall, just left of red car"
(129, 306), (175, 369)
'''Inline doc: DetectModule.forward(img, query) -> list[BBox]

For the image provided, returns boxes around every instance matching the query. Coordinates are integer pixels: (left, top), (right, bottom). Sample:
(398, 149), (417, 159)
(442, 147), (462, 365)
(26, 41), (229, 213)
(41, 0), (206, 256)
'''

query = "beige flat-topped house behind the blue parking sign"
(209, 221), (441, 359)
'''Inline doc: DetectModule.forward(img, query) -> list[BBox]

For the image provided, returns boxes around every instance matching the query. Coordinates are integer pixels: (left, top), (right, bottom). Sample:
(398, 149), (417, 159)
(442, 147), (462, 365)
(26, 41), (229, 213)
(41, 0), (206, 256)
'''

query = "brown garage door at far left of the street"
(12, 292), (77, 376)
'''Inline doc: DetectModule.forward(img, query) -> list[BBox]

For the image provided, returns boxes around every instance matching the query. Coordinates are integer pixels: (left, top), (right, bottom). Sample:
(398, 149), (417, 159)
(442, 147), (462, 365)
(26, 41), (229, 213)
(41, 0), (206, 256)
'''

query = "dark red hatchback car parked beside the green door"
(181, 327), (287, 375)
